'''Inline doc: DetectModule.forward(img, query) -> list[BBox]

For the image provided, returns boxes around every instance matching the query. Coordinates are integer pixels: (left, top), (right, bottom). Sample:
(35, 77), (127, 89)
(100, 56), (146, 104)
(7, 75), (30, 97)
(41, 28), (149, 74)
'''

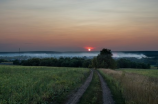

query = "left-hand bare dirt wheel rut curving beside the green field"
(65, 70), (93, 104)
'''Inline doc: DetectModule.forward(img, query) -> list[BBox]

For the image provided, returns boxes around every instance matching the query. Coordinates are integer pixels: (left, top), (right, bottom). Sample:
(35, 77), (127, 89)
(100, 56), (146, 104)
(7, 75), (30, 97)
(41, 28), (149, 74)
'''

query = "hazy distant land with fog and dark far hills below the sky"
(0, 51), (158, 59)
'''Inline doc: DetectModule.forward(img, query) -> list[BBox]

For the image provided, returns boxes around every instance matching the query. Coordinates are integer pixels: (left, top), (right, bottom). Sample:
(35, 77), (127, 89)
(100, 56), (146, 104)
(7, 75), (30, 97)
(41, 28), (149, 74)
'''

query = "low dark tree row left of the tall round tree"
(13, 57), (91, 68)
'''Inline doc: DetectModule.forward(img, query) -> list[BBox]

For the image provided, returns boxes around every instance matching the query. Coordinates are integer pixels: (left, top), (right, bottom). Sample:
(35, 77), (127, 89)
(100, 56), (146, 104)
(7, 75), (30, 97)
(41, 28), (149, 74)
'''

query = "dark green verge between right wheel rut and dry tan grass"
(99, 70), (125, 104)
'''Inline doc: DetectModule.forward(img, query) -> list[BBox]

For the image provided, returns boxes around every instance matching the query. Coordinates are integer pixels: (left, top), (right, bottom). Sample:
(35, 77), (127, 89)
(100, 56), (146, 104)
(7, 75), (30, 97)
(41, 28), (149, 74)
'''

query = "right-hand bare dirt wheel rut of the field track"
(97, 72), (115, 104)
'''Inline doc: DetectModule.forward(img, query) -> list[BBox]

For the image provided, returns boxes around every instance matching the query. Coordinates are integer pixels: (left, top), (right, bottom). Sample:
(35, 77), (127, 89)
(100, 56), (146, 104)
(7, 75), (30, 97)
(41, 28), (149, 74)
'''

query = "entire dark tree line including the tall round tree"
(13, 49), (150, 69)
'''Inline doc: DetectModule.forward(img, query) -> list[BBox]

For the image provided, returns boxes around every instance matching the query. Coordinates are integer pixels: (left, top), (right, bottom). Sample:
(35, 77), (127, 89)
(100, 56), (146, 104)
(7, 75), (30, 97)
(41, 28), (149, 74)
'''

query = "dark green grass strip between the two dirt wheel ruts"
(78, 71), (103, 104)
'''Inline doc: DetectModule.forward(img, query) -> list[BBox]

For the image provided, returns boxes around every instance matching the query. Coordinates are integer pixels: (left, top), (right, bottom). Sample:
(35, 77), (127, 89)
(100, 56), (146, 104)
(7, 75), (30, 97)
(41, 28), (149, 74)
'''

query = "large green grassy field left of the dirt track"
(0, 66), (90, 104)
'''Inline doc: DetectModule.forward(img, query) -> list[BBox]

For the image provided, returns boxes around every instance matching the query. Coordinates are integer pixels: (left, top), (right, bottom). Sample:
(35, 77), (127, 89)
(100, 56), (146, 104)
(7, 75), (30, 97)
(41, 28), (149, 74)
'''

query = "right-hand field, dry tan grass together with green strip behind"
(100, 69), (158, 104)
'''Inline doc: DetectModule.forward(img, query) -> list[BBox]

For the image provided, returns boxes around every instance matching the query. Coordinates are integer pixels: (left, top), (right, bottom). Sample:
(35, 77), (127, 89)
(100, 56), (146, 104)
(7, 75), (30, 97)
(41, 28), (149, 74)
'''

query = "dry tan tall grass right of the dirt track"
(100, 69), (158, 104)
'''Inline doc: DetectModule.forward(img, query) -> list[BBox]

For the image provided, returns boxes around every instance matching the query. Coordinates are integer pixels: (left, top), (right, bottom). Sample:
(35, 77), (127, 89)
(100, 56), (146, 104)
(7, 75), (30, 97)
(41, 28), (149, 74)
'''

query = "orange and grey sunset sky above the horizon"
(0, 0), (158, 52)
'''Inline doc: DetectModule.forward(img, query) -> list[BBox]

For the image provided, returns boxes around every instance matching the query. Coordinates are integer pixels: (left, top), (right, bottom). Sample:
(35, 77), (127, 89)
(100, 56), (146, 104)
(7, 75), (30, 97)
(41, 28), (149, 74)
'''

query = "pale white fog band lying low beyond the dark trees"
(0, 52), (147, 59)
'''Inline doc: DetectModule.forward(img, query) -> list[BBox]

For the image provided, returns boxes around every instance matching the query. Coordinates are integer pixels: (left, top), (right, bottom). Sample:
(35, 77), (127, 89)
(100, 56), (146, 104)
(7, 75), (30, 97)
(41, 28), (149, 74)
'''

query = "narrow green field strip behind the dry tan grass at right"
(119, 69), (158, 78)
